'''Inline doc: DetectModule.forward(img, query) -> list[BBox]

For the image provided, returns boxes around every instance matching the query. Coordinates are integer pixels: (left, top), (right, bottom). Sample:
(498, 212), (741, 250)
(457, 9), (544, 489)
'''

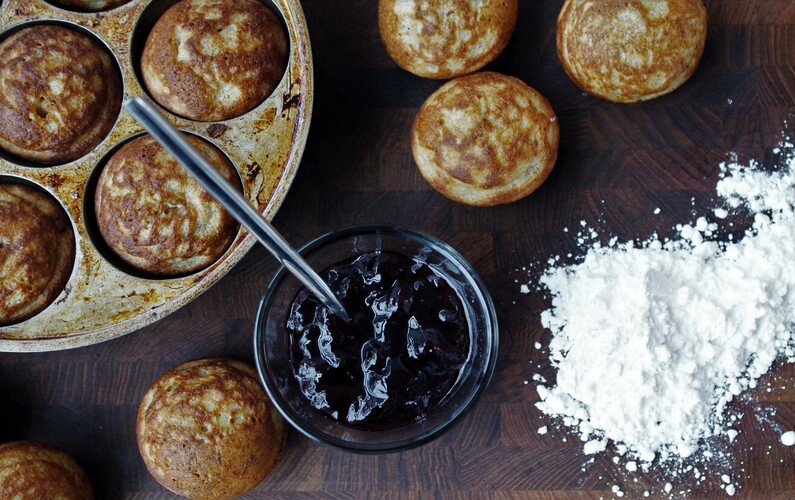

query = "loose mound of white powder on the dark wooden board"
(538, 144), (795, 464)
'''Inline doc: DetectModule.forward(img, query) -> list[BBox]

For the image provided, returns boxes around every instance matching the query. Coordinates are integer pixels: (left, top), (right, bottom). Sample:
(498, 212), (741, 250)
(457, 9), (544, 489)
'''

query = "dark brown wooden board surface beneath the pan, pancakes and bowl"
(0, 0), (795, 498)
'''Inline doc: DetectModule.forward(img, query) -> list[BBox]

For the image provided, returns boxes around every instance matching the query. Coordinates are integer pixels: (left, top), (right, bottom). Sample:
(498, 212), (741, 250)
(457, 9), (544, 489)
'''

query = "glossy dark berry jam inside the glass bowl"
(287, 252), (470, 430)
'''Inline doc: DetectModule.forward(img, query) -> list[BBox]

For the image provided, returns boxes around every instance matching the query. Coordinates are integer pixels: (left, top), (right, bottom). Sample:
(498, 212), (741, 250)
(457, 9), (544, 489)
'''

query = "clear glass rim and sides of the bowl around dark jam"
(254, 225), (498, 453)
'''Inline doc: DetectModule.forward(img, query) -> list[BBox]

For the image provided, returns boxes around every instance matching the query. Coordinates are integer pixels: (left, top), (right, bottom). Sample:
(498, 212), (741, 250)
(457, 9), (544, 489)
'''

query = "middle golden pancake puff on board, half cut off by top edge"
(378, 0), (519, 79)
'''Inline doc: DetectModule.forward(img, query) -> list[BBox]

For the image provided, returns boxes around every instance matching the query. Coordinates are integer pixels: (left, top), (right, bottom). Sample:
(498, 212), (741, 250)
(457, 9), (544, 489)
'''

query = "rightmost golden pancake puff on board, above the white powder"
(557, 0), (707, 103)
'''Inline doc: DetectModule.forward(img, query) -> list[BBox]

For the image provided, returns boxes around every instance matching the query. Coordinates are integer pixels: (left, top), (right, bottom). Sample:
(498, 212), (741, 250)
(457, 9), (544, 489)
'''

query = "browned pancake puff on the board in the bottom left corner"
(0, 441), (94, 500)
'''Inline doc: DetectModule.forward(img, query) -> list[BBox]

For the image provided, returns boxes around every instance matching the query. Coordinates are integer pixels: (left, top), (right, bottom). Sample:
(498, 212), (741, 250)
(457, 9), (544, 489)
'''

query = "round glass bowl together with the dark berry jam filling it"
(254, 225), (498, 453)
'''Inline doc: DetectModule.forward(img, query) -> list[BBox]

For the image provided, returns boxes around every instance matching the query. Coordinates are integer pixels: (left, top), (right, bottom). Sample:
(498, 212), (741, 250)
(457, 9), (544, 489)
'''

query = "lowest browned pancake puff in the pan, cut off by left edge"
(0, 184), (75, 324)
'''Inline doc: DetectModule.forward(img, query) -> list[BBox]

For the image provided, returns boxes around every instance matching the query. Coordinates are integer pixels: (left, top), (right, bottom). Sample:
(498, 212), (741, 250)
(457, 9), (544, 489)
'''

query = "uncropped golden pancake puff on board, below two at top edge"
(411, 72), (560, 206)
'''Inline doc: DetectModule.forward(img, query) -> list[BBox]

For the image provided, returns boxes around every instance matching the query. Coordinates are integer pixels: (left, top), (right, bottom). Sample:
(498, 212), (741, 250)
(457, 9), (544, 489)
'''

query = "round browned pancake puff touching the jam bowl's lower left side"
(137, 359), (287, 498)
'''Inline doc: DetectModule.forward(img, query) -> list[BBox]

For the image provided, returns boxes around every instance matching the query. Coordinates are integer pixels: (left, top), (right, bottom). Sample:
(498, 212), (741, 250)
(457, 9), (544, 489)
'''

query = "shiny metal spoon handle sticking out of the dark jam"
(124, 97), (350, 322)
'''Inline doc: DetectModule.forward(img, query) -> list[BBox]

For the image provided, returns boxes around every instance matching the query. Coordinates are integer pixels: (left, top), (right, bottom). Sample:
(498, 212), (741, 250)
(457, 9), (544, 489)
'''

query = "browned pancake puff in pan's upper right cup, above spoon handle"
(141, 0), (289, 121)
